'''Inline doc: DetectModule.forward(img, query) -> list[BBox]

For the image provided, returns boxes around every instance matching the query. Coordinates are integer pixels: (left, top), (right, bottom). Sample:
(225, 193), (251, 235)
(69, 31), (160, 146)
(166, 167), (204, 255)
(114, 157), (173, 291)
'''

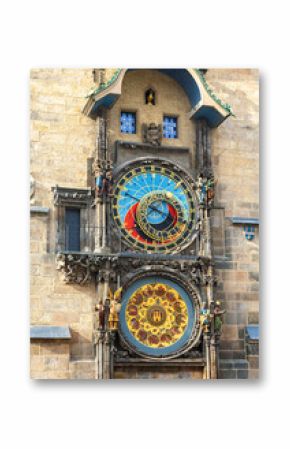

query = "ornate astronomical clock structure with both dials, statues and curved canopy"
(55, 69), (230, 379)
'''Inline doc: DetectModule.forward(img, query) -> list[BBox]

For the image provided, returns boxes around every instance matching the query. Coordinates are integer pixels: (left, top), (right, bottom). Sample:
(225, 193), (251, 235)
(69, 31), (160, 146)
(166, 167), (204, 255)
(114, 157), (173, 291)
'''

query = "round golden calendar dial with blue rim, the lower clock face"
(120, 276), (197, 357)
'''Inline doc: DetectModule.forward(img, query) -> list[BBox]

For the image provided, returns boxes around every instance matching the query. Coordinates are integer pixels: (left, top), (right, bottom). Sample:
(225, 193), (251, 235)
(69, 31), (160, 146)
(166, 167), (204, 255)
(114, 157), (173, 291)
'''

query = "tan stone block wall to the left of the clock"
(30, 69), (95, 372)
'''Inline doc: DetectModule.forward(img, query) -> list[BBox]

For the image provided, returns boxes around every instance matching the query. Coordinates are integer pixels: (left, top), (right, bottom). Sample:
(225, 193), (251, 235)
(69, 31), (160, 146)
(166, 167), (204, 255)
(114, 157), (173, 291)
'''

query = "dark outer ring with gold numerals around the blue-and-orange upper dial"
(112, 157), (199, 254)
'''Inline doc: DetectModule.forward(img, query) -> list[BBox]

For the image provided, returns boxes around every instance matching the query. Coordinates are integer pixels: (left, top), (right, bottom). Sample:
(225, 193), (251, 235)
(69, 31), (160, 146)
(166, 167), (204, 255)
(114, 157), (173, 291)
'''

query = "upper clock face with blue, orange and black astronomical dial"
(113, 160), (196, 252)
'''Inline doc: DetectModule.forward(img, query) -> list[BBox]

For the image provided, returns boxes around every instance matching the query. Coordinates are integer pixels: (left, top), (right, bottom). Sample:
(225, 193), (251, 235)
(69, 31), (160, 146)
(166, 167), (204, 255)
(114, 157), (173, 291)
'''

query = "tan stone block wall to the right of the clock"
(206, 69), (259, 377)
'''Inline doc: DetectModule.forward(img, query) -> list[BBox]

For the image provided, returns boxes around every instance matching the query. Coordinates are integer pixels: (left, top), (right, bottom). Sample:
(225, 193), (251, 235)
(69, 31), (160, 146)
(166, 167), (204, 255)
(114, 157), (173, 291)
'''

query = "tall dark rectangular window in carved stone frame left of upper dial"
(65, 207), (81, 251)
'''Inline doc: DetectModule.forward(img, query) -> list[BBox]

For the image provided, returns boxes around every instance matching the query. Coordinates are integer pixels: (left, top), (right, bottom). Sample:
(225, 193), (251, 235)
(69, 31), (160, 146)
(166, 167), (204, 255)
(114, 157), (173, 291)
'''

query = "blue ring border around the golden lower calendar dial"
(119, 269), (202, 360)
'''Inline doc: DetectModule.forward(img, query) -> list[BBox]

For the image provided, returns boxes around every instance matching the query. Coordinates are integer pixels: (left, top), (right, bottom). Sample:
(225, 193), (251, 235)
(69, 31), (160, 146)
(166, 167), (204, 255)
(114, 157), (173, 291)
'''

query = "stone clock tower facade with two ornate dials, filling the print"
(30, 68), (259, 379)
